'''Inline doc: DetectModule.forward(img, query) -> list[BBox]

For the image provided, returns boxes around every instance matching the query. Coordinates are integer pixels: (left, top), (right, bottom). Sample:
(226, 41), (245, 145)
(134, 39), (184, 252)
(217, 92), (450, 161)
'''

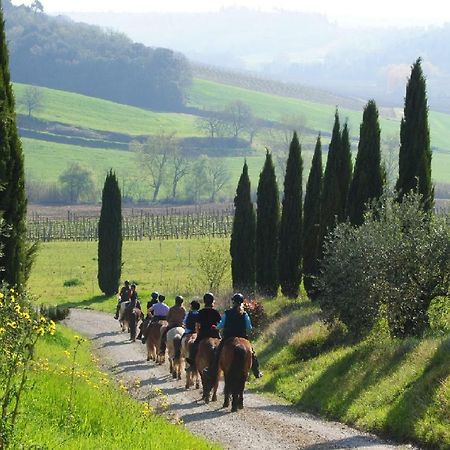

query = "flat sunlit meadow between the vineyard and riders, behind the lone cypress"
(28, 239), (231, 312)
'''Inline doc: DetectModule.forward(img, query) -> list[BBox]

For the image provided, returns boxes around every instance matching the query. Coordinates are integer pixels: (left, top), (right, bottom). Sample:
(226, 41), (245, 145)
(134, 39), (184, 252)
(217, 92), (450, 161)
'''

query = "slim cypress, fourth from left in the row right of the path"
(303, 135), (322, 298)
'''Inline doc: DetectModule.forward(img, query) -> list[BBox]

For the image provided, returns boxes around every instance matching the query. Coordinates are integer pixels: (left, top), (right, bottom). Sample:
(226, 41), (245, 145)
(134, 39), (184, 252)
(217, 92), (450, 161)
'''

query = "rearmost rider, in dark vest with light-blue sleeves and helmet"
(206, 293), (262, 379)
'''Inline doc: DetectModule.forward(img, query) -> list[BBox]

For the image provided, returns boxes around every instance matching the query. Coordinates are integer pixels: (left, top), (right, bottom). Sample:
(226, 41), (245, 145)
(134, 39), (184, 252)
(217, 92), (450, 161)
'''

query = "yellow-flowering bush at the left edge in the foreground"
(0, 285), (55, 450)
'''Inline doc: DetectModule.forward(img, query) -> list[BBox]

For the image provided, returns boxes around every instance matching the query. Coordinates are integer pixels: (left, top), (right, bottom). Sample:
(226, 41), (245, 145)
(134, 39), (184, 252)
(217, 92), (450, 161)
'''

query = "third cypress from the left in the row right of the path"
(278, 132), (303, 298)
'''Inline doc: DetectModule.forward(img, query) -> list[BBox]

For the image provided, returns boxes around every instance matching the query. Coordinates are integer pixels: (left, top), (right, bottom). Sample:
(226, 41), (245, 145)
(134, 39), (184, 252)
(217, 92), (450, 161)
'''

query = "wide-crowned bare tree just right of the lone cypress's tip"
(130, 131), (178, 202)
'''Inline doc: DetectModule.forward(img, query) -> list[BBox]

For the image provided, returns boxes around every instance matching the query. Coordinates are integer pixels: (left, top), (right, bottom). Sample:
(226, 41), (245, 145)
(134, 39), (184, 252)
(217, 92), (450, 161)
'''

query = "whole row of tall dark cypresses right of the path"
(230, 58), (434, 298)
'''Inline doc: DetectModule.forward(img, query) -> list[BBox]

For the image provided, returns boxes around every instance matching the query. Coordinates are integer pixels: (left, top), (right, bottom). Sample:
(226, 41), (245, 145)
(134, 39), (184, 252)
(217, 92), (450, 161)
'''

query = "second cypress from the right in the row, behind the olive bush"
(347, 100), (383, 226)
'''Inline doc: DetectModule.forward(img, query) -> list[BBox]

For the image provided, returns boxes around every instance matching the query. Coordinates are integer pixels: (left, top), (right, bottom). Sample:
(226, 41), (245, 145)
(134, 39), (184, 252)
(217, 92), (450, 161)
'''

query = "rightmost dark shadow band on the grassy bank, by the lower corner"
(386, 337), (450, 449)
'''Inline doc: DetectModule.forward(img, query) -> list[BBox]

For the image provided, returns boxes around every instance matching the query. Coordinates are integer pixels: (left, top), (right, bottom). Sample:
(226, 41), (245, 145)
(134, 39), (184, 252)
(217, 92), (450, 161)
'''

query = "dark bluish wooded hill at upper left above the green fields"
(2, 0), (191, 111)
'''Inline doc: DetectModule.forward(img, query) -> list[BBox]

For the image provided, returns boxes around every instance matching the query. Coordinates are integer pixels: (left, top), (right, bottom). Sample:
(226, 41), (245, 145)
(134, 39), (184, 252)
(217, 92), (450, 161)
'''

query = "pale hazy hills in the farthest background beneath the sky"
(66, 8), (450, 112)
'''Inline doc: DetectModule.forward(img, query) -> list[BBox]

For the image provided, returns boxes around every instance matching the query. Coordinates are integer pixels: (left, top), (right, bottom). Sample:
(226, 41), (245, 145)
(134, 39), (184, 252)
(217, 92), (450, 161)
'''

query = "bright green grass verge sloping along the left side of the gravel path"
(17, 325), (219, 450)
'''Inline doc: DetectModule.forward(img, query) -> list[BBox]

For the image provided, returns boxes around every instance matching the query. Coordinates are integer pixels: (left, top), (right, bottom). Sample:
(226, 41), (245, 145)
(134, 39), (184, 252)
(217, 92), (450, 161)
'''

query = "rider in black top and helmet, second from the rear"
(186, 292), (221, 370)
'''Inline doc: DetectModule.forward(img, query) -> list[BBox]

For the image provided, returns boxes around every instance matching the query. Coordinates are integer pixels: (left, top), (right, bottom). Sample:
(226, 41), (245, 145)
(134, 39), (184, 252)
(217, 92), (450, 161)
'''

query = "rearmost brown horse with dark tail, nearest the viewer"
(219, 337), (252, 412)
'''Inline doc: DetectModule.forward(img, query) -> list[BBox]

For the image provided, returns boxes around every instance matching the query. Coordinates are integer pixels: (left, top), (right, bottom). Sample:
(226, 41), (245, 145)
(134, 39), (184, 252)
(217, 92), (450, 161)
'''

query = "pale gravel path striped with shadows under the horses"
(65, 309), (412, 450)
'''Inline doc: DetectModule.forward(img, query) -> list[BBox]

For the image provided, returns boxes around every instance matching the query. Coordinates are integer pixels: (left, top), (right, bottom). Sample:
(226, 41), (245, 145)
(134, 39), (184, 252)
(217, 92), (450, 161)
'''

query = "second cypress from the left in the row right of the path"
(256, 151), (280, 297)
